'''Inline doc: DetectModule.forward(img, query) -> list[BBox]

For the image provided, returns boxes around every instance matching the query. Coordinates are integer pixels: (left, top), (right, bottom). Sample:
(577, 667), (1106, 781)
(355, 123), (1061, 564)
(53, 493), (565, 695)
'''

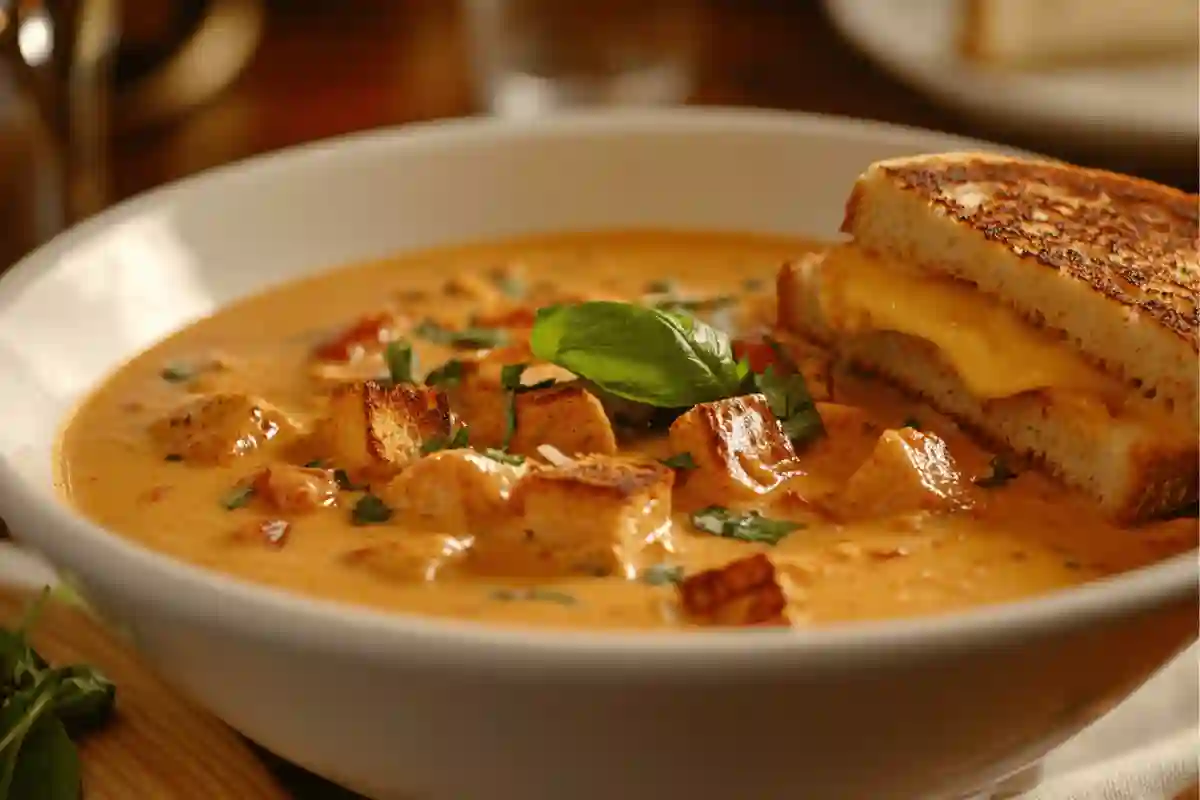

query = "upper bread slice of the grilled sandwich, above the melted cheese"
(842, 152), (1200, 431)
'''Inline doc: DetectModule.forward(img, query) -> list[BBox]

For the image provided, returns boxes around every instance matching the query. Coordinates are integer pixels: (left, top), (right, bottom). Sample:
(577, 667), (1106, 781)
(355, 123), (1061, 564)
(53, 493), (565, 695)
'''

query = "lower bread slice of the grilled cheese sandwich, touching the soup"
(779, 254), (1200, 522)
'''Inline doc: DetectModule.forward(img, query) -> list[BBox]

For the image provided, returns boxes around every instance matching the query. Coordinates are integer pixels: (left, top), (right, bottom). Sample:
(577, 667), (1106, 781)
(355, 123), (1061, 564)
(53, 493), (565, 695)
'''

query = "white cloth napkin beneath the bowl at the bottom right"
(1016, 645), (1200, 800)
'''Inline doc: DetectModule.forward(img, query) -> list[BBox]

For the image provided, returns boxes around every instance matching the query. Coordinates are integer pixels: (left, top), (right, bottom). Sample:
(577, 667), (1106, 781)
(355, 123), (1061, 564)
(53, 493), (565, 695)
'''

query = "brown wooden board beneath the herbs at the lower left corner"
(0, 588), (292, 800)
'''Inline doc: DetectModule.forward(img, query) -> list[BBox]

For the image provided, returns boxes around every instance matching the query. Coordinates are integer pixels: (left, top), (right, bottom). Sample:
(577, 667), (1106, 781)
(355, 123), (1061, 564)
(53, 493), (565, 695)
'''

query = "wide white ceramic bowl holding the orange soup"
(0, 110), (1196, 800)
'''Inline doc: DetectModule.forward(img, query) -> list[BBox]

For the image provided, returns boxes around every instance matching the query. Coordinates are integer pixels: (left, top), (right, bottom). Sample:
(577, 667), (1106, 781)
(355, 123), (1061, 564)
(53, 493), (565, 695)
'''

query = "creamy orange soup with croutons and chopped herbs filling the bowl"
(60, 231), (1195, 627)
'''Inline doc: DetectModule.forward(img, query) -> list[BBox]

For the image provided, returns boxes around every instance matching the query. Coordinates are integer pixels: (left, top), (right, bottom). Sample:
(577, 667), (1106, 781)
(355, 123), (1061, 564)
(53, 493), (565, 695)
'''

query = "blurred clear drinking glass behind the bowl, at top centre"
(463, 0), (700, 116)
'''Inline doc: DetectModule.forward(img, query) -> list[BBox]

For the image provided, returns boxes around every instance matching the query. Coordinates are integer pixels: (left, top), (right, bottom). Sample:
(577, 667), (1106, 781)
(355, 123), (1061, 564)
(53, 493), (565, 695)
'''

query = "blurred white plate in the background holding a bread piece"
(826, 0), (1200, 166)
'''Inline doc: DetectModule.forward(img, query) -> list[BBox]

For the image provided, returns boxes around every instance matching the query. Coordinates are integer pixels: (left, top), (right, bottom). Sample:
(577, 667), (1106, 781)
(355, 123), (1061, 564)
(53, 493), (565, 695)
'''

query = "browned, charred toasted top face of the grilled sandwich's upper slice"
(841, 154), (1200, 351)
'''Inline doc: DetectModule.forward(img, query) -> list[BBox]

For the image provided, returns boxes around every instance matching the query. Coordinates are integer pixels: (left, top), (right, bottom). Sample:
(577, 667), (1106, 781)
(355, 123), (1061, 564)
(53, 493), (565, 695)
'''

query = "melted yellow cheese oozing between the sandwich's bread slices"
(820, 247), (1121, 399)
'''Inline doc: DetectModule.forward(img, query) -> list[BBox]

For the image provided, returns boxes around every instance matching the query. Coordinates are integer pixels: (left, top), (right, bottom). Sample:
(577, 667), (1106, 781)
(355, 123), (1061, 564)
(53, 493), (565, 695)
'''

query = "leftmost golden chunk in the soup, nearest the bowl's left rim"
(150, 393), (295, 465)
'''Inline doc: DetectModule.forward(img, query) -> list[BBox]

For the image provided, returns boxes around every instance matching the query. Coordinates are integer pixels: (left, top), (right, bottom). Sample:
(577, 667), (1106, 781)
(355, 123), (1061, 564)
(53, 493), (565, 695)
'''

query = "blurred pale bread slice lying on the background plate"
(959, 0), (1200, 67)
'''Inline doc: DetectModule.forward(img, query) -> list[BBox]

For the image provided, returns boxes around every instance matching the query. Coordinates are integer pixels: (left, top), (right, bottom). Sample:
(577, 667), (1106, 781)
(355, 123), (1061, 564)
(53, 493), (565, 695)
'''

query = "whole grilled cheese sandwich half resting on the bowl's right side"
(779, 154), (1200, 522)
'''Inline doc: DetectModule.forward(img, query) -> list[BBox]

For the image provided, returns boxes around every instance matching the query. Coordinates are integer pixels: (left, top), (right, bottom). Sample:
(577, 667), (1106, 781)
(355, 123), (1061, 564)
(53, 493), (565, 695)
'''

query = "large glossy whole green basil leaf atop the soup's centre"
(530, 301), (748, 408)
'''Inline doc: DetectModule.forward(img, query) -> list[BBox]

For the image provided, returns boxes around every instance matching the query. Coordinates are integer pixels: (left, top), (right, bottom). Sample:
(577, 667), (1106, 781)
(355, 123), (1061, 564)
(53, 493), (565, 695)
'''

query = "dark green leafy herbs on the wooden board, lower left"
(0, 588), (116, 800)
